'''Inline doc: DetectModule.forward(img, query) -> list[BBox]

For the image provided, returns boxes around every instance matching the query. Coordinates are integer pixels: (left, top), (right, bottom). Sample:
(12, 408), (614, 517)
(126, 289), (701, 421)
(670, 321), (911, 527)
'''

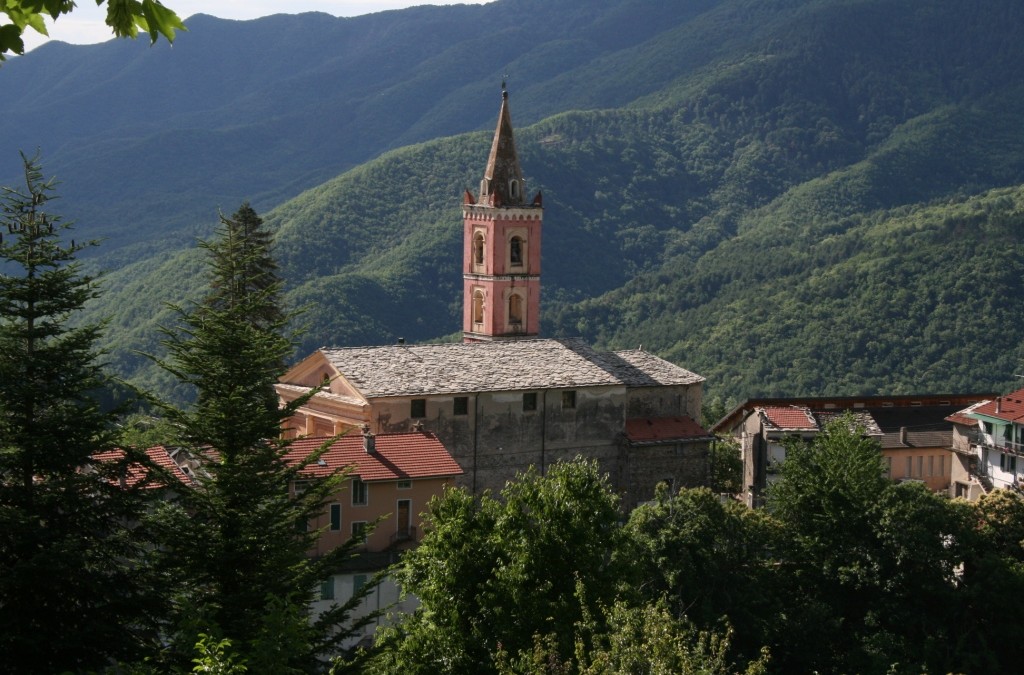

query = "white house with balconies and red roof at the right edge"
(947, 389), (1024, 499)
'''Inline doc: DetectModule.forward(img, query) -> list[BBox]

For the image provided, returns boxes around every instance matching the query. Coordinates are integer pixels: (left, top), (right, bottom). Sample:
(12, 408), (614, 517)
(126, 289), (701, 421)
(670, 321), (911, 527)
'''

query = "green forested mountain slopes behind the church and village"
(0, 0), (1024, 398)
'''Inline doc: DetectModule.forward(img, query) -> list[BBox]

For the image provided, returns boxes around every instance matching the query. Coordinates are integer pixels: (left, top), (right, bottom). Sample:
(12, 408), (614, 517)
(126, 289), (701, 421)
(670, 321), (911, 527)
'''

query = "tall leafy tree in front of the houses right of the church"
(768, 415), (889, 671)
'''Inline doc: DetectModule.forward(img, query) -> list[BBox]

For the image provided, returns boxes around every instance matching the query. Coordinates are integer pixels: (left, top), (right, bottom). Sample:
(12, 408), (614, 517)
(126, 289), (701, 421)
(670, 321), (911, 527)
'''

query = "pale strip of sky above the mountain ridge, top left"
(23, 0), (485, 49)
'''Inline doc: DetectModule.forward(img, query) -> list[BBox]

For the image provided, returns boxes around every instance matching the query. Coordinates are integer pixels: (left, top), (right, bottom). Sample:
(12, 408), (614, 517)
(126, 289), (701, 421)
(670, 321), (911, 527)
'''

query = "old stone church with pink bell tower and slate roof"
(278, 85), (712, 508)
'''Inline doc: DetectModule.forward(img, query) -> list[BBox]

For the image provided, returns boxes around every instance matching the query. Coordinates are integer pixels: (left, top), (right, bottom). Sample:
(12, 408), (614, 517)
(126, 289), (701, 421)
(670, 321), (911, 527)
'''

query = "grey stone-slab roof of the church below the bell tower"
(321, 338), (703, 397)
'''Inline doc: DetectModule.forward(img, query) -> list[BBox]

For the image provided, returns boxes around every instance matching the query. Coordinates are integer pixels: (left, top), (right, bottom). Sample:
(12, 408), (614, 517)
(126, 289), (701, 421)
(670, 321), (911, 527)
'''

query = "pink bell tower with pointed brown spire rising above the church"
(462, 82), (544, 342)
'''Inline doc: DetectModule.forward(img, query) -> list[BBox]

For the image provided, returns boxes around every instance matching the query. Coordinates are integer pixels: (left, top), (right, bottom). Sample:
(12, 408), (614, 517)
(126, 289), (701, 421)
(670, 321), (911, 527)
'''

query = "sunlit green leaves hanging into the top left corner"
(0, 0), (188, 60)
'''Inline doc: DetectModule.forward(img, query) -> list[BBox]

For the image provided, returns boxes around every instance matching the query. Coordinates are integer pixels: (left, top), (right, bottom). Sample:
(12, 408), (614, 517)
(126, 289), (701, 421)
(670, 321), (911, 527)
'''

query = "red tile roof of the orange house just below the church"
(287, 431), (463, 482)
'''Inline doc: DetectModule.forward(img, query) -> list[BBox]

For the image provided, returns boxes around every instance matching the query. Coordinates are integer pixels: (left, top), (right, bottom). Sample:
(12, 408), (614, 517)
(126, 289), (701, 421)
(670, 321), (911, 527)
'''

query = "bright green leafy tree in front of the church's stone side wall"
(374, 460), (620, 673)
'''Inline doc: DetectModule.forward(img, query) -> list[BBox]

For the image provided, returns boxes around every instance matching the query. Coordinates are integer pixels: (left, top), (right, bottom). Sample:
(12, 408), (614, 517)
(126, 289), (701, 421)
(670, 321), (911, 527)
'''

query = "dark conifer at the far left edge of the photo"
(0, 156), (156, 673)
